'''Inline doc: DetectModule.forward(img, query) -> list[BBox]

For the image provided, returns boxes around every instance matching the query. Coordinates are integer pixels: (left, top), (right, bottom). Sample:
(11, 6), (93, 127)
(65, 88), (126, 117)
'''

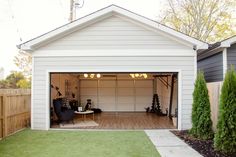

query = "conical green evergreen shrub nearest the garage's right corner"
(190, 72), (213, 139)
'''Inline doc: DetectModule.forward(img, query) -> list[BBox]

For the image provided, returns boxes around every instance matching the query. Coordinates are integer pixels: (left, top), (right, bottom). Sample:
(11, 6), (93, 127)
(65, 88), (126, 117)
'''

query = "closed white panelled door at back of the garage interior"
(80, 77), (153, 112)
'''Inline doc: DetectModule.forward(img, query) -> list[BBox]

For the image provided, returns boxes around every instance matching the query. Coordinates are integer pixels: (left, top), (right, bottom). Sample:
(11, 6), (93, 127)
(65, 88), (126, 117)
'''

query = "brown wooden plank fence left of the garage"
(0, 89), (31, 139)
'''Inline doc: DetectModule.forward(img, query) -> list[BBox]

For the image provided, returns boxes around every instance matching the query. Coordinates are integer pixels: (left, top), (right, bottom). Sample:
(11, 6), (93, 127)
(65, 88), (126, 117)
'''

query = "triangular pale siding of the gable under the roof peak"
(40, 16), (189, 50)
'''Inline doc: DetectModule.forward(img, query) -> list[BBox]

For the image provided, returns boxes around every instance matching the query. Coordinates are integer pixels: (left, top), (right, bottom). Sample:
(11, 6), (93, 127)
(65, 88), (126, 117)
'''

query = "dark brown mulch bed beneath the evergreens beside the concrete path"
(172, 130), (236, 157)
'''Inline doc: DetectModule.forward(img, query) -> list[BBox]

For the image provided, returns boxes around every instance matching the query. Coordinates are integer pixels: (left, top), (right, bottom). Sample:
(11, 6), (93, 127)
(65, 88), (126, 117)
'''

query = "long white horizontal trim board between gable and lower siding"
(32, 49), (196, 57)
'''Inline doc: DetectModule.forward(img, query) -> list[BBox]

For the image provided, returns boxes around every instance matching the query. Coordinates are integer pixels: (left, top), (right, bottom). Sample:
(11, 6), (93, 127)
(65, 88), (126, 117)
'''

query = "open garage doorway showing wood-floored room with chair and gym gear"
(50, 72), (178, 129)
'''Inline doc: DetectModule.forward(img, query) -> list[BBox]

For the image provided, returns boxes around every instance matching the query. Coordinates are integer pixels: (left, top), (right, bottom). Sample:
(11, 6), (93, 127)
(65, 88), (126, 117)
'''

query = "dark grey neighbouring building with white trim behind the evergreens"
(197, 36), (236, 82)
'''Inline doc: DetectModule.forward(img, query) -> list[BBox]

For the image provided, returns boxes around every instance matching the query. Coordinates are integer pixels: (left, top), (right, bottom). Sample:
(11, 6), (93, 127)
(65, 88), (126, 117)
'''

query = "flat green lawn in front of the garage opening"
(0, 129), (160, 157)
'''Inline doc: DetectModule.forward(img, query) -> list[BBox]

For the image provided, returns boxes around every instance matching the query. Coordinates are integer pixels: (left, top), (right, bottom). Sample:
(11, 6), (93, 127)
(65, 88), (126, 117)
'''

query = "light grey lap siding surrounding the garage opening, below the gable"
(33, 57), (194, 129)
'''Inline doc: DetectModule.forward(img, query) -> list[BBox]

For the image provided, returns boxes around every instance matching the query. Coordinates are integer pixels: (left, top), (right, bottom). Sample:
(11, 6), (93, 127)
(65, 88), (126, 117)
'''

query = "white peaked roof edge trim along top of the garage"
(17, 5), (208, 51)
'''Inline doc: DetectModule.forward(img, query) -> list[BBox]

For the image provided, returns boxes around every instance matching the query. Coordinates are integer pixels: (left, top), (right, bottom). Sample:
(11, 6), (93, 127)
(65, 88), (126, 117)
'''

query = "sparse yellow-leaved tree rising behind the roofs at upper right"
(161, 0), (236, 42)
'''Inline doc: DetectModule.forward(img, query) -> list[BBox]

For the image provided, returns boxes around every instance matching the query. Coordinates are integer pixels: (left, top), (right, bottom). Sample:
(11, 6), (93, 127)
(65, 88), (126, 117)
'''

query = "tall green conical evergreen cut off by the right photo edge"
(214, 68), (236, 153)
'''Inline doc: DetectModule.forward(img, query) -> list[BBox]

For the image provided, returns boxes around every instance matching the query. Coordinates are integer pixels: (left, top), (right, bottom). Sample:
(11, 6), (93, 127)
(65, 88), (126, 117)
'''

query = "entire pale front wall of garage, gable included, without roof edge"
(32, 16), (196, 129)
